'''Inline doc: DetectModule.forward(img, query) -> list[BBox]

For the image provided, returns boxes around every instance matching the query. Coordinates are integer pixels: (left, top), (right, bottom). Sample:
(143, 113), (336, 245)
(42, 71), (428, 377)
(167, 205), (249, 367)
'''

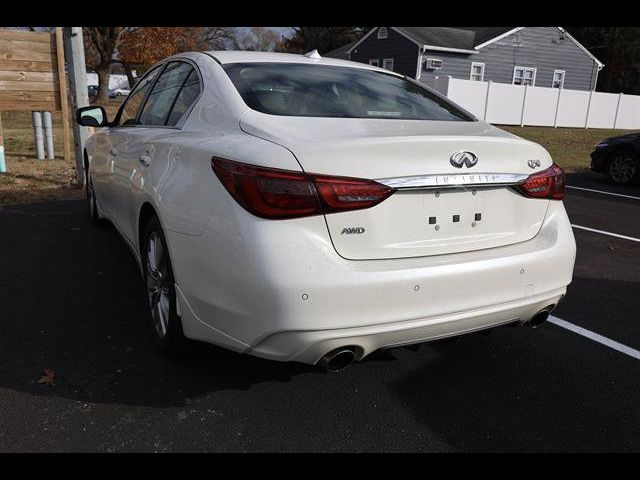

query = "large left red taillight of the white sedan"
(211, 157), (394, 219)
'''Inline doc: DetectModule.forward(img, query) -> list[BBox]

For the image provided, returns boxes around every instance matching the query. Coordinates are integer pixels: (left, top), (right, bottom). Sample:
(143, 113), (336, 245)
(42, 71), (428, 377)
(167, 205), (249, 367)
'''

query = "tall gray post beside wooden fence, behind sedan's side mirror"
(63, 27), (89, 188)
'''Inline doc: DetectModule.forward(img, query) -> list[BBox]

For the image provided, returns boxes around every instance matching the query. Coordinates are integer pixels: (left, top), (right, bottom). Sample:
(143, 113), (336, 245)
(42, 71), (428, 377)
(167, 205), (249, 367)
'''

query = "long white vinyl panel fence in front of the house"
(447, 78), (640, 130)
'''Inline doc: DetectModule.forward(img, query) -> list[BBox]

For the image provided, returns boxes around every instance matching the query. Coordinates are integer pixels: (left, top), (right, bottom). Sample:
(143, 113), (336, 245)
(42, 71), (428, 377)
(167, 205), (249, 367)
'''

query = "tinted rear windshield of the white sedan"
(223, 63), (473, 121)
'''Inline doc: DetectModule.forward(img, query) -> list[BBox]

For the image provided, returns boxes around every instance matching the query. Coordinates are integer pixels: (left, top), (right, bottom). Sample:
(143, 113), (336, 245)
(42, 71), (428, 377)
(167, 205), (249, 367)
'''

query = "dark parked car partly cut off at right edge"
(591, 132), (640, 185)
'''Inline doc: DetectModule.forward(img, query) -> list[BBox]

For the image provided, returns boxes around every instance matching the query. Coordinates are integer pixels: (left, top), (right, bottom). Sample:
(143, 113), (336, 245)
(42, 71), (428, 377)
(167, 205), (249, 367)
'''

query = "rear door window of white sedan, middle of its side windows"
(140, 62), (192, 125)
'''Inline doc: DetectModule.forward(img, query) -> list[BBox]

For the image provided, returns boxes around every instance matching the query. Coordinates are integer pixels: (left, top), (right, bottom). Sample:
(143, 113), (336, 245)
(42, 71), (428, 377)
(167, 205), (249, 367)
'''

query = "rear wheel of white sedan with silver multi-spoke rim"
(140, 216), (186, 355)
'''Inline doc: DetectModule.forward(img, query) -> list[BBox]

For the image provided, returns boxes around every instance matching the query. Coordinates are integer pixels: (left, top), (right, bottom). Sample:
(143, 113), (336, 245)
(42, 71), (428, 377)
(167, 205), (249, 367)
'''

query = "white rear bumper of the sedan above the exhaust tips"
(169, 202), (576, 363)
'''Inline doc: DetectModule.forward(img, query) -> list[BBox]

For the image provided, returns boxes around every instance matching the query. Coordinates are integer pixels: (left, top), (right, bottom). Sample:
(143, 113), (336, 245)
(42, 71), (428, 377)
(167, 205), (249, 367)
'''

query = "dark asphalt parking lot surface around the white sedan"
(0, 173), (640, 452)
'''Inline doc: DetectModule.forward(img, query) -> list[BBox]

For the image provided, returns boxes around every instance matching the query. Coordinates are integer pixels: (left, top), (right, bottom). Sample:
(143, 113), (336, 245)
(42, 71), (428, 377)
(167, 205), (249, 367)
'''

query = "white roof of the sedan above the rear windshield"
(203, 50), (402, 77)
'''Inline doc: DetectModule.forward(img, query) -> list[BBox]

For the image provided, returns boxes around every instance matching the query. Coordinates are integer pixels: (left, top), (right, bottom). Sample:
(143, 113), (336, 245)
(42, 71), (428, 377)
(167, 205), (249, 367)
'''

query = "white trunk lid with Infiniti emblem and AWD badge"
(241, 111), (552, 260)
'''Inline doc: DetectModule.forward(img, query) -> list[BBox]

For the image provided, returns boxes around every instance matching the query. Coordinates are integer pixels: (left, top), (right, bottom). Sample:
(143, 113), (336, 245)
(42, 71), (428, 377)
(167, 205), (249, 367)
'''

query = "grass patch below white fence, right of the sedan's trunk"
(498, 125), (632, 172)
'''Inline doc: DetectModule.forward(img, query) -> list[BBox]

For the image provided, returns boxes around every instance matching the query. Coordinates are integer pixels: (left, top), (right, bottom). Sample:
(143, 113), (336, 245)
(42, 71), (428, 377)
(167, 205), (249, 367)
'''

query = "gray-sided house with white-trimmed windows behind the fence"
(325, 27), (604, 90)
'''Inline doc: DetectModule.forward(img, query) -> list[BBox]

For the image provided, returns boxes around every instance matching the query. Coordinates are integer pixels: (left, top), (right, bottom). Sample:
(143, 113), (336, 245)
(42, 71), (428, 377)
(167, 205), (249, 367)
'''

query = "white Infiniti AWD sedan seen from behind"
(77, 51), (576, 370)
